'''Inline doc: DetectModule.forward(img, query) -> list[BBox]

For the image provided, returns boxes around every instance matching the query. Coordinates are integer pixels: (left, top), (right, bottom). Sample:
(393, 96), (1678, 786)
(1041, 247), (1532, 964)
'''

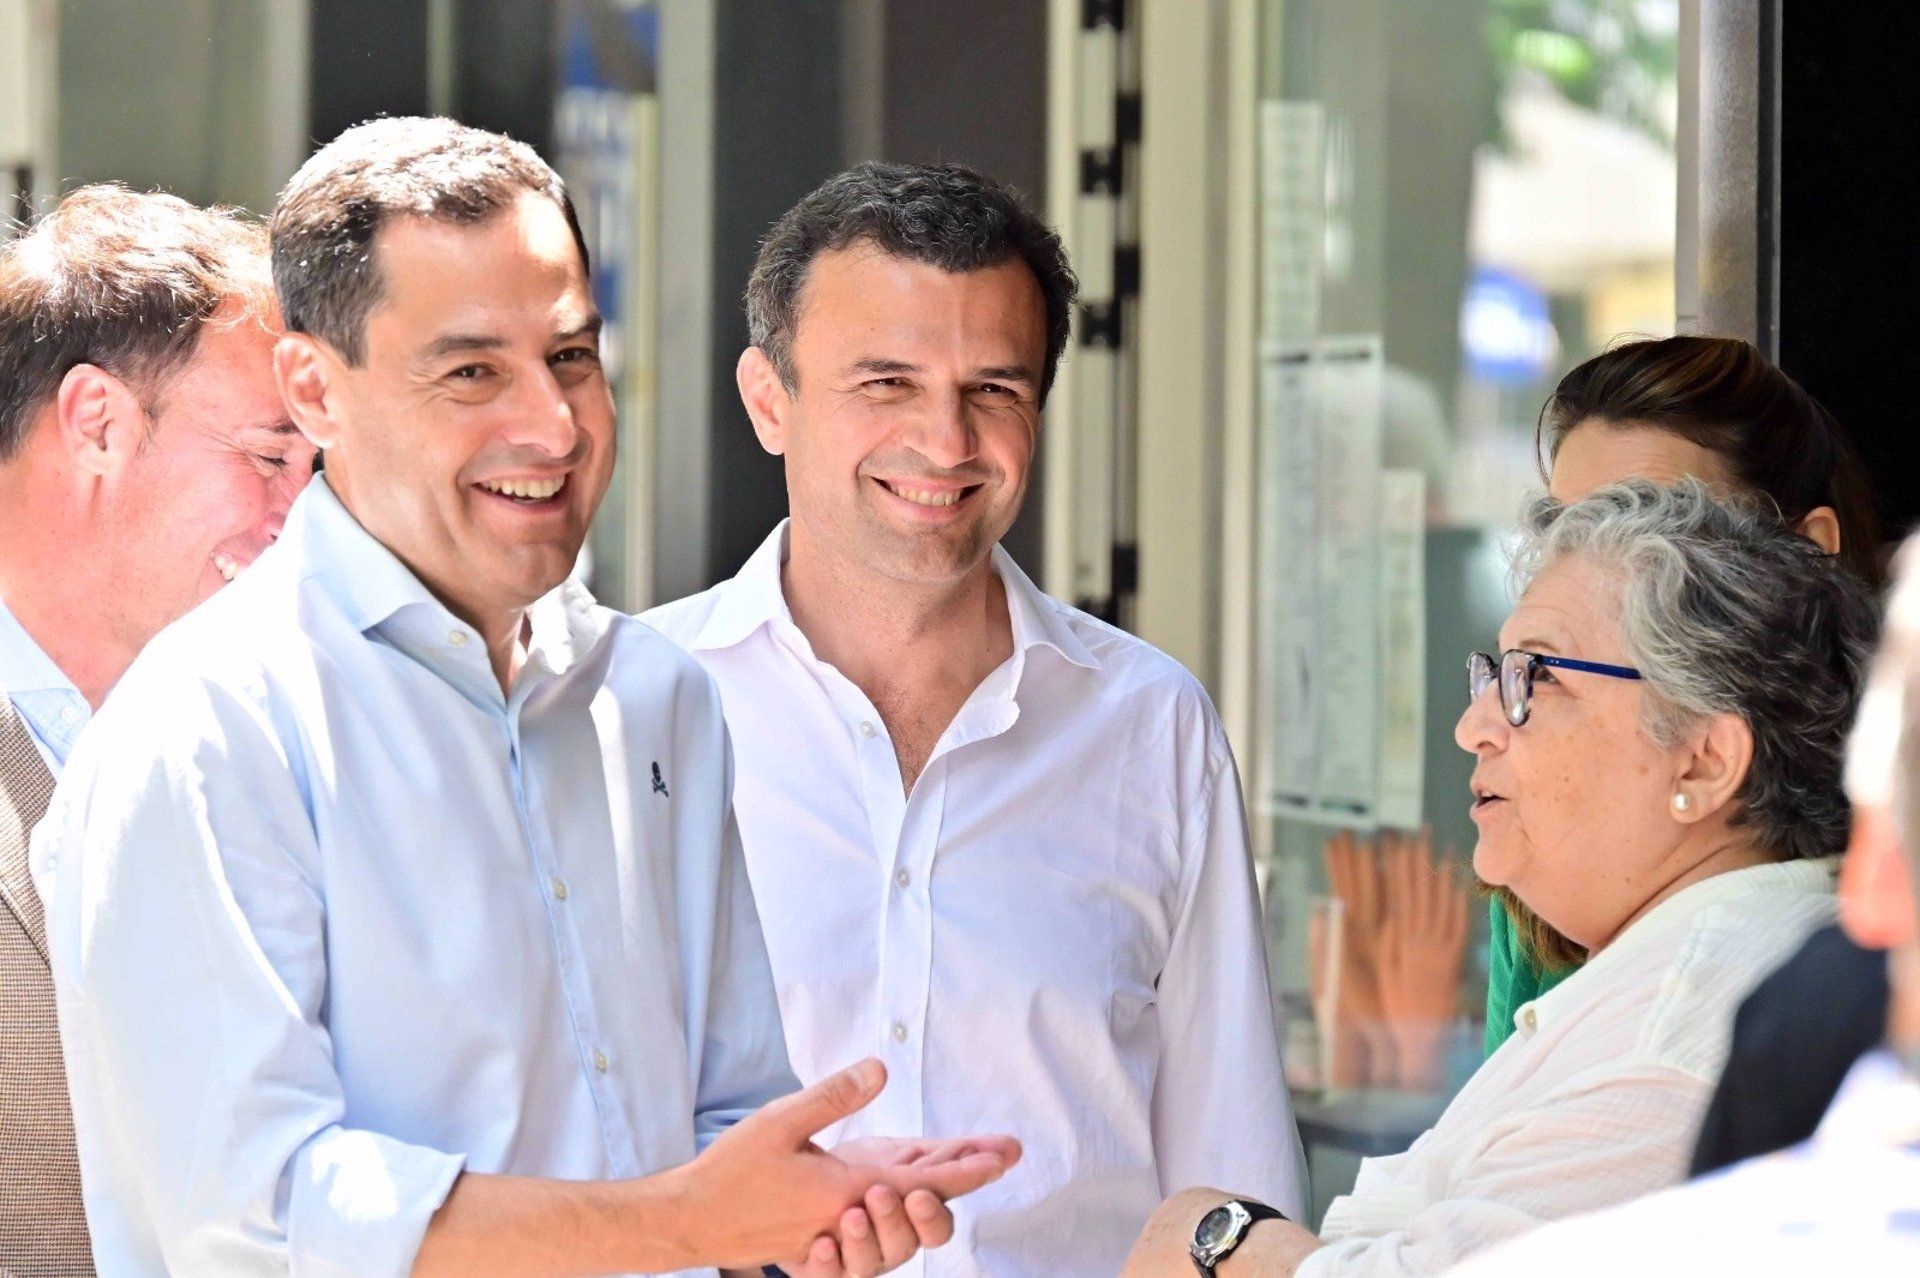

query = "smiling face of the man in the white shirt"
(741, 244), (1046, 585)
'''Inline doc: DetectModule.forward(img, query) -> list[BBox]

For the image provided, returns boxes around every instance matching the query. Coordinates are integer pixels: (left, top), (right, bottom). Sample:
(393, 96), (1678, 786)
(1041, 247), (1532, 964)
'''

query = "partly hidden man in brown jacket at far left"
(0, 186), (313, 1278)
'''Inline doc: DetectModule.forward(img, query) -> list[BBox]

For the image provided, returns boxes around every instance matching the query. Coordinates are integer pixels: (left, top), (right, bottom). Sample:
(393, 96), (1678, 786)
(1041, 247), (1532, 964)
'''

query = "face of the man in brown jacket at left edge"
(109, 303), (313, 643)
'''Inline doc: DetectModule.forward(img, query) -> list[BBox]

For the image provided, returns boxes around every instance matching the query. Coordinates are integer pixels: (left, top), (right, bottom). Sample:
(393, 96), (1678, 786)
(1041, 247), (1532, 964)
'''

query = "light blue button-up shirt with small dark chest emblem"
(35, 480), (793, 1278)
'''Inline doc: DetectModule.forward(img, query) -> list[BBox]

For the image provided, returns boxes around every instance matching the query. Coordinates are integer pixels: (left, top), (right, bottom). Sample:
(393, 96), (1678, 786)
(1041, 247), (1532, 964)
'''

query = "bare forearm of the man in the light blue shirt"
(413, 1172), (712, 1278)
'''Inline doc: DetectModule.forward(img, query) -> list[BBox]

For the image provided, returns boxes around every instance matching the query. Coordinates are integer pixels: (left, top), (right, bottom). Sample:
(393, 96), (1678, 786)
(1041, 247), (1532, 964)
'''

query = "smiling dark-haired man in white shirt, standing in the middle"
(643, 165), (1304, 1278)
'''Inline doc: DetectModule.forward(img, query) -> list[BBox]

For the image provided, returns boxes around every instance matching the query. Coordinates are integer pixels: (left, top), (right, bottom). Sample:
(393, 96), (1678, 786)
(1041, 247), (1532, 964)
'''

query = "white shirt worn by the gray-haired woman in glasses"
(1298, 862), (1834, 1278)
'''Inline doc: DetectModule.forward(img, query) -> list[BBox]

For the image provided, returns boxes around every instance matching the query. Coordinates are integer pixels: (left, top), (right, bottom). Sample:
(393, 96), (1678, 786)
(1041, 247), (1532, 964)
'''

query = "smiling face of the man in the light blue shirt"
(280, 192), (614, 635)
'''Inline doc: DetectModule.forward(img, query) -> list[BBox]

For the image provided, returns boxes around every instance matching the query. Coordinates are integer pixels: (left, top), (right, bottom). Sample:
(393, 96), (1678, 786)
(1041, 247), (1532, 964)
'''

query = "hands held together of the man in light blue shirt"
(695, 1059), (1020, 1278)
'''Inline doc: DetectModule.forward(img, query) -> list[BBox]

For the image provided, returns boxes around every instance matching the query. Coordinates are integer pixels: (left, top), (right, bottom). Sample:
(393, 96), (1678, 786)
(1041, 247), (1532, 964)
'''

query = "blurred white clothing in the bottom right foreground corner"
(1457, 1052), (1920, 1278)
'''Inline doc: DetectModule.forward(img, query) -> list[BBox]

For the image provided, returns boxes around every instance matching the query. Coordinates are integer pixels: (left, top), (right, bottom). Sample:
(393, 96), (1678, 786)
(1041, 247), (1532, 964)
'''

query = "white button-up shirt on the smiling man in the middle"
(643, 526), (1304, 1278)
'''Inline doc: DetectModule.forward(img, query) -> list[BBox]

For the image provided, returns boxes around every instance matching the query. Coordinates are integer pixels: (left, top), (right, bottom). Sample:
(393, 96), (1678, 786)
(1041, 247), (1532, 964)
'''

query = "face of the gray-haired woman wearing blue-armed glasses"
(1453, 558), (1686, 948)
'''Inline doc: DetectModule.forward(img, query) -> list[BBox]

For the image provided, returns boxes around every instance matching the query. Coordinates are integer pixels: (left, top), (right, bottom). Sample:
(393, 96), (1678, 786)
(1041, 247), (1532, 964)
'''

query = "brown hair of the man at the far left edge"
(0, 184), (273, 461)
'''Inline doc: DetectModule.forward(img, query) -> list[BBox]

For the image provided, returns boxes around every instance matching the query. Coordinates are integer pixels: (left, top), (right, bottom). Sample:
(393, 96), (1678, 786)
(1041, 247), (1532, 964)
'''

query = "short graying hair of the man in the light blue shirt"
(273, 115), (588, 367)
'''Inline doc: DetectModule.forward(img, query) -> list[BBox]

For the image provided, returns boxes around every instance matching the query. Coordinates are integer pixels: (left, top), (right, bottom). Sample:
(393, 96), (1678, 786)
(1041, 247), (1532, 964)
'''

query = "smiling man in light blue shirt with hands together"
(35, 119), (1016, 1278)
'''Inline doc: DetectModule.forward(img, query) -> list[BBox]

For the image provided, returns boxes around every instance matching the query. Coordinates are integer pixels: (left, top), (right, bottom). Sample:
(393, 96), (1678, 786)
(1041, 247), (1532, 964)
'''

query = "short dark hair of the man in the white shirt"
(747, 163), (1079, 401)
